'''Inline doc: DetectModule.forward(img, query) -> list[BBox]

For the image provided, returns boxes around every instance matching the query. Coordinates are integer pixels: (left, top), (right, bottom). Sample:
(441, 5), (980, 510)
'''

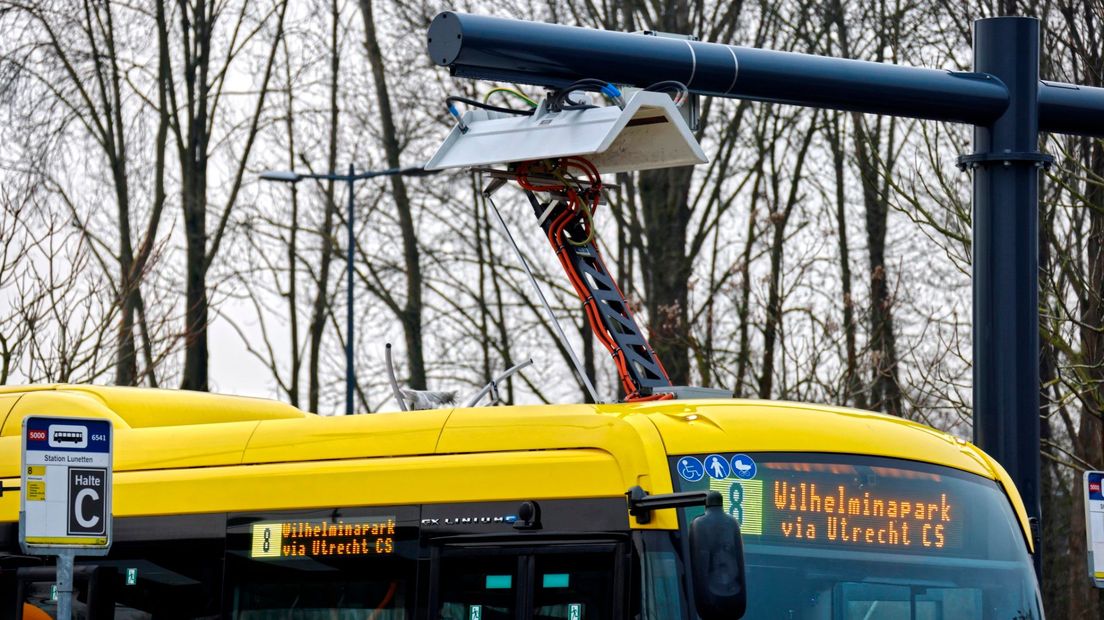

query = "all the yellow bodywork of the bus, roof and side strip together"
(0, 385), (1032, 548)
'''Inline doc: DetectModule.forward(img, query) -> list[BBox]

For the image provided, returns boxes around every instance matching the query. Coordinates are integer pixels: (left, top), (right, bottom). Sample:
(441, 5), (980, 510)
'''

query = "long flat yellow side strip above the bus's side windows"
(114, 450), (627, 511)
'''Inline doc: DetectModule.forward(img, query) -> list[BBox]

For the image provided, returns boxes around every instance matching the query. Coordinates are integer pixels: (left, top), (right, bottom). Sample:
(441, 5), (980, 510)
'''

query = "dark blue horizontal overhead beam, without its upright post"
(428, 12), (1104, 136)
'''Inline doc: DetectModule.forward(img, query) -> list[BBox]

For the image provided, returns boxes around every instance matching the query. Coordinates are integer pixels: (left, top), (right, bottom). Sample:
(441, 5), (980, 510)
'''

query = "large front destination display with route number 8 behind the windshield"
(676, 455), (966, 554)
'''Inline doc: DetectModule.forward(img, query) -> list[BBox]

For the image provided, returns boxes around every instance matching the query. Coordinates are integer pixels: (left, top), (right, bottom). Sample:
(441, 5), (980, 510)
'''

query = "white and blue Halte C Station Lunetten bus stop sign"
(19, 416), (112, 555)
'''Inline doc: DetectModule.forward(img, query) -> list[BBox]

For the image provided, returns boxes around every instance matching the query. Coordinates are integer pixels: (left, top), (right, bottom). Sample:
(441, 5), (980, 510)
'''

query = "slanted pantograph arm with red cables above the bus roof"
(514, 157), (673, 402)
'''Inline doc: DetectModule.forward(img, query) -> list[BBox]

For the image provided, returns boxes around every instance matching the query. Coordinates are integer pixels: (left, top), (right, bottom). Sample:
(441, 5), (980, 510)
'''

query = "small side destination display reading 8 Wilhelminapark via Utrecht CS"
(250, 516), (396, 558)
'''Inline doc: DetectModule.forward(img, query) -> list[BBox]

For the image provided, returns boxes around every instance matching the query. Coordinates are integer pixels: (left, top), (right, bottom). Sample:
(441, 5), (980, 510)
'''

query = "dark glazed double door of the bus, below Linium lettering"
(429, 536), (629, 620)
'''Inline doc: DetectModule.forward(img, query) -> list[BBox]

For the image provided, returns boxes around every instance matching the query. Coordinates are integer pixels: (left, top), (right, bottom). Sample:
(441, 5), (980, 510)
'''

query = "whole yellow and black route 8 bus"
(0, 385), (1042, 620)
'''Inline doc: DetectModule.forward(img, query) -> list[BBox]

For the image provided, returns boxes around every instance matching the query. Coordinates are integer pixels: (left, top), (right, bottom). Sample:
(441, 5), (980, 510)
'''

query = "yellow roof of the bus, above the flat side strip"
(0, 385), (1028, 547)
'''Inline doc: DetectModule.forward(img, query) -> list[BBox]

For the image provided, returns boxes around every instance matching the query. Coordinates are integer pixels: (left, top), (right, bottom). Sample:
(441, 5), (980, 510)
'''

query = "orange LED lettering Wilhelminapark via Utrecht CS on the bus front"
(774, 481), (954, 548)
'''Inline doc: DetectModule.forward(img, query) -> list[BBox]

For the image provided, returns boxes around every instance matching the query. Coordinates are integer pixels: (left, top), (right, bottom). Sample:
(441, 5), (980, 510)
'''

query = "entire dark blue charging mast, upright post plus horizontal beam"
(428, 12), (1104, 569)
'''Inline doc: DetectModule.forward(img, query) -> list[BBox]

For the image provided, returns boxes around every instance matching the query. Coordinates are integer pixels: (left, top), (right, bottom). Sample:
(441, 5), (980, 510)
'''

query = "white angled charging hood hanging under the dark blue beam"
(425, 90), (709, 173)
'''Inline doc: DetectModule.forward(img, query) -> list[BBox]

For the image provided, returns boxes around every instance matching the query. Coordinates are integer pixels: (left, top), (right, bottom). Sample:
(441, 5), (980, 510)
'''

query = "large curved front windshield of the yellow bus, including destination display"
(671, 452), (1042, 620)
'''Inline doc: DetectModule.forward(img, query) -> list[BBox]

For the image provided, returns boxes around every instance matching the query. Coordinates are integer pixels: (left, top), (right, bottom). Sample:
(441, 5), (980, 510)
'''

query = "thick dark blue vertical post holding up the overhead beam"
(959, 18), (1050, 578)
